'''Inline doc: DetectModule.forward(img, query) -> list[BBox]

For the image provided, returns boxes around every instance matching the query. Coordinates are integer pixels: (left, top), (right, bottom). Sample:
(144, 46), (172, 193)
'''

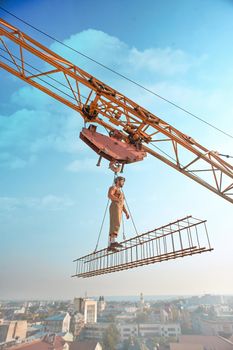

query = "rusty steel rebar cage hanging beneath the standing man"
(72, 216), (213, 278)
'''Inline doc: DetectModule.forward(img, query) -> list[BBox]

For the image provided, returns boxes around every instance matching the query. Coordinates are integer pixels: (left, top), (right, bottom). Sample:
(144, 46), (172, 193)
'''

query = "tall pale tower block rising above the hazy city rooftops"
(74, 298), (97, 324)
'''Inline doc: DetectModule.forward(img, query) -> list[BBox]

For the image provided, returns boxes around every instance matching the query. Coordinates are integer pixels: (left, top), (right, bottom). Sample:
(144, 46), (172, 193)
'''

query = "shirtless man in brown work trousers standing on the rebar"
(108, 176), (129, 249)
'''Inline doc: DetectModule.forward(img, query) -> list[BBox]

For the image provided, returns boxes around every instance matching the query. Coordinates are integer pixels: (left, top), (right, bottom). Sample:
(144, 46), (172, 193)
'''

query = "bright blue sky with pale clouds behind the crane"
(0, 0), (233, 299)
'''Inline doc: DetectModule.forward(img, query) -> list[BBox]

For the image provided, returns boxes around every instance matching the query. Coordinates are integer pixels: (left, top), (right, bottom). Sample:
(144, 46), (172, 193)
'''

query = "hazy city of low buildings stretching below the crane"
(0, 293), (233, 350)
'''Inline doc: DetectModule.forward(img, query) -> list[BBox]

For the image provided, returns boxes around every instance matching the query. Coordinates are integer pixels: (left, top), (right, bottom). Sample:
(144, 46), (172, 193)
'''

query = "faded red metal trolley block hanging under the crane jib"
(80, 125), (146, 164)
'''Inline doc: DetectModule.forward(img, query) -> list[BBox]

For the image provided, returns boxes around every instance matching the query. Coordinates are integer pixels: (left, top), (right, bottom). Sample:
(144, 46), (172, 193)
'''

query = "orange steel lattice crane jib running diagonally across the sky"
(0, 19), (233, 203)
